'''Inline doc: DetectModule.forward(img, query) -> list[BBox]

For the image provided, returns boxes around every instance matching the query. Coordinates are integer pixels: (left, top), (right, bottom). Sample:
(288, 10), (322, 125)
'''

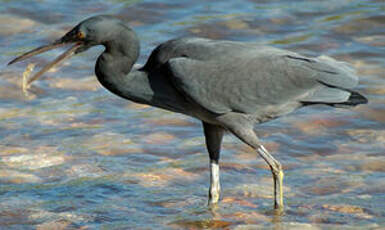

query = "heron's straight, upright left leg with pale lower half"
(203, 122), (224, 205)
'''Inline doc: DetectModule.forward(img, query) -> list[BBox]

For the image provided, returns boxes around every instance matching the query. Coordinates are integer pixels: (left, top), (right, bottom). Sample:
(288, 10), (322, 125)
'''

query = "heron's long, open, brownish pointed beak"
(8, 30), (84, 84)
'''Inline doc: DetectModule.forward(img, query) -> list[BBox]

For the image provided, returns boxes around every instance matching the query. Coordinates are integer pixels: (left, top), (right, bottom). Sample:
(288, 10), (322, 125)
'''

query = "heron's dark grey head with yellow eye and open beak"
(8, 15), (131, 83)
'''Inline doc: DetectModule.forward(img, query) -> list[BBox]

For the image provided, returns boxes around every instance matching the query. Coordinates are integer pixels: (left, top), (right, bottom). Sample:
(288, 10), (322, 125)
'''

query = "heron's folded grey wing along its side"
(165, 47), (358, 114)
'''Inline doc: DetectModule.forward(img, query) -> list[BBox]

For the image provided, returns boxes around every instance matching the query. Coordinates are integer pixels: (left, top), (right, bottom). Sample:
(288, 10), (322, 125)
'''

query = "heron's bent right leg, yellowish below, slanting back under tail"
(218, 113), (283, 211)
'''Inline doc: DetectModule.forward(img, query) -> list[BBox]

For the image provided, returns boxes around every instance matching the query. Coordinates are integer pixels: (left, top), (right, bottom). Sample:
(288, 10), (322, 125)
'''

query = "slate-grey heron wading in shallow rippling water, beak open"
(9, 15), (368, 210)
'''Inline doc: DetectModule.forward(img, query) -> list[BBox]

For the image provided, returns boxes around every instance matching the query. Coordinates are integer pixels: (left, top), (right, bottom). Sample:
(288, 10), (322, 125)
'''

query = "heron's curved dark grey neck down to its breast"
(95, 28), (187, 113)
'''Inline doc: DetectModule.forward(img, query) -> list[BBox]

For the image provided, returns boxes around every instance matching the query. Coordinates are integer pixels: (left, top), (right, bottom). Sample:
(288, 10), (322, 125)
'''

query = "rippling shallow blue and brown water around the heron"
(0, 0), (385, 229)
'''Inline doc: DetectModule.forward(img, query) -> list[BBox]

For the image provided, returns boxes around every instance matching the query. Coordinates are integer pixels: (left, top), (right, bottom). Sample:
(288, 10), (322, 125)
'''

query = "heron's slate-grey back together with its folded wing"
(143, 38), (363, 120)
